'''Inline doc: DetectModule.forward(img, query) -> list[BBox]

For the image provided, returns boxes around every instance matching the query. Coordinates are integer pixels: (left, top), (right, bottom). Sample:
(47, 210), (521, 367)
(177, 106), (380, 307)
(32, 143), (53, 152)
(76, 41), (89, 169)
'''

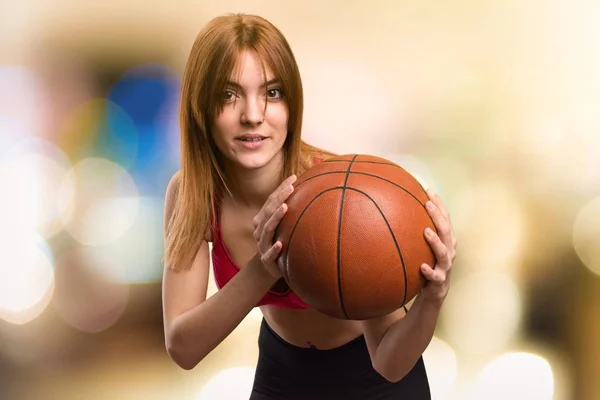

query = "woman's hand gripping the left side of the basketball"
(252, 175), (296, 279)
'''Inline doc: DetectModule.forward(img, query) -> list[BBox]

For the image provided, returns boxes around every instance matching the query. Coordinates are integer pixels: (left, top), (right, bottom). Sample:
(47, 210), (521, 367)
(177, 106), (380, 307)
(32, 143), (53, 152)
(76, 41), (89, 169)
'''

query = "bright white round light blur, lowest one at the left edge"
(0, 230), (54, 324)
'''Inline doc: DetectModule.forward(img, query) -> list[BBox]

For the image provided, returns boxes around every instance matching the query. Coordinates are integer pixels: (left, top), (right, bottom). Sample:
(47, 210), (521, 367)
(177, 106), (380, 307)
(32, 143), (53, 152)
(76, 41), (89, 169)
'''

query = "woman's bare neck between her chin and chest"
(225, 154), (283, 209)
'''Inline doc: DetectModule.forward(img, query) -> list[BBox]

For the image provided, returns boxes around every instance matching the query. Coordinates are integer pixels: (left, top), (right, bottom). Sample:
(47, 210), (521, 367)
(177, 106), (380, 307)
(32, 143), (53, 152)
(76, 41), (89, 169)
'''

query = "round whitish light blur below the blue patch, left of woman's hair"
(58, 158), (139, 246)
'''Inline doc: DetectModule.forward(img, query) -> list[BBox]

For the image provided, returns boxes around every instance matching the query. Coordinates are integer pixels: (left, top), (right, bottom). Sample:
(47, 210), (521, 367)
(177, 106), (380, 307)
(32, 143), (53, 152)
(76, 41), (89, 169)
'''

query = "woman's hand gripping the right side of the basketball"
(421, 189), (456, 305)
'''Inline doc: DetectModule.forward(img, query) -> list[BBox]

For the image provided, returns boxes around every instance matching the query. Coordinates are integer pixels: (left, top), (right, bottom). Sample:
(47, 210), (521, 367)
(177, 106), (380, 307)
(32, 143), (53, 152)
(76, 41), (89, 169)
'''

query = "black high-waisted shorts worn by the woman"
(250, 319), (431, 400)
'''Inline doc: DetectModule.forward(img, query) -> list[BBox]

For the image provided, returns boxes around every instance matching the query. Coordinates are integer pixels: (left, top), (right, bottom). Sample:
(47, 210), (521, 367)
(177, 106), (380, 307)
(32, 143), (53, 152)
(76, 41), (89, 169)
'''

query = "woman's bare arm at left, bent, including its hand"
(162, 171), (298, 370)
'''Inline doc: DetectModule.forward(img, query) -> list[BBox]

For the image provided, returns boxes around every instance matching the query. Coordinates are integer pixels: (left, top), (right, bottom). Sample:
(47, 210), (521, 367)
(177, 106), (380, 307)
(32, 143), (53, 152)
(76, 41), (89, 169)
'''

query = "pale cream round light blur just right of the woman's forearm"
(441, 272), (522, 354)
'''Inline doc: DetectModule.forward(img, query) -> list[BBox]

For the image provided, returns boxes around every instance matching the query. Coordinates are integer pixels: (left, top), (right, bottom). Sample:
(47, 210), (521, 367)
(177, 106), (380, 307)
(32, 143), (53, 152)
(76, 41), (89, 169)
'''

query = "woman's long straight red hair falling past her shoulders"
(165, 14), (331, 269)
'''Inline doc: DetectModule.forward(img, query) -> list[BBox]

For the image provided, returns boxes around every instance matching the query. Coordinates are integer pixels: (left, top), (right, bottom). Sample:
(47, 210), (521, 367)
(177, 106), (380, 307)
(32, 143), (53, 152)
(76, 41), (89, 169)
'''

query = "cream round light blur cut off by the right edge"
(573, 197), (600, 275)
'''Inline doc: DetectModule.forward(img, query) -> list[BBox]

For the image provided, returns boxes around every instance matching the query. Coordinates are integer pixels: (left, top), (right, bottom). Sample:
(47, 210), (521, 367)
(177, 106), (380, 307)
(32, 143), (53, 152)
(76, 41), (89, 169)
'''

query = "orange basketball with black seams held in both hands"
(275, 154), (436, 320)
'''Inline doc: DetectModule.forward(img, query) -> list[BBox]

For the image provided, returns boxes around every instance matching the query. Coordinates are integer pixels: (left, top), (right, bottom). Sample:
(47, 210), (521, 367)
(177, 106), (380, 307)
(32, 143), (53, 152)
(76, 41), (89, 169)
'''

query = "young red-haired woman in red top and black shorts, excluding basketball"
(163, 15), (456, 400)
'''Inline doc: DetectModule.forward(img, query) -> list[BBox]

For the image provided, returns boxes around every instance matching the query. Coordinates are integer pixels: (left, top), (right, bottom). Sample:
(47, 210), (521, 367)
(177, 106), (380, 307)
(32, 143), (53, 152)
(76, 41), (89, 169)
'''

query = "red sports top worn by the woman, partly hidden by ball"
(211, 159), (322, 309)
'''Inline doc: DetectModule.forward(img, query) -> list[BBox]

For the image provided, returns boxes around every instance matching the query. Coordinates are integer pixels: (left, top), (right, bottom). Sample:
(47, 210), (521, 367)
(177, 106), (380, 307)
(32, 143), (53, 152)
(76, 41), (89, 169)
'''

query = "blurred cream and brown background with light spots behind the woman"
(0, 0), (600, 400)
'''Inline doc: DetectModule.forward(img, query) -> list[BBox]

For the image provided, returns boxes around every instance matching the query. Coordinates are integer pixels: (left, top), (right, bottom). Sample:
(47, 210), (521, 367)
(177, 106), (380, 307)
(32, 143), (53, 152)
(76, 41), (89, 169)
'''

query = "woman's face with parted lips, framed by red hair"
(212, 51), (288, 169)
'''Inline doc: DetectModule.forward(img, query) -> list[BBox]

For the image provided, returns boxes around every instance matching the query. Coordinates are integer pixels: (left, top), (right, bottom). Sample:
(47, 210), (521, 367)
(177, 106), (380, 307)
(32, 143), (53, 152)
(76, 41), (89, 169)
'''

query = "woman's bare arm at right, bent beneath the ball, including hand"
(363, 191), (456, 382)
